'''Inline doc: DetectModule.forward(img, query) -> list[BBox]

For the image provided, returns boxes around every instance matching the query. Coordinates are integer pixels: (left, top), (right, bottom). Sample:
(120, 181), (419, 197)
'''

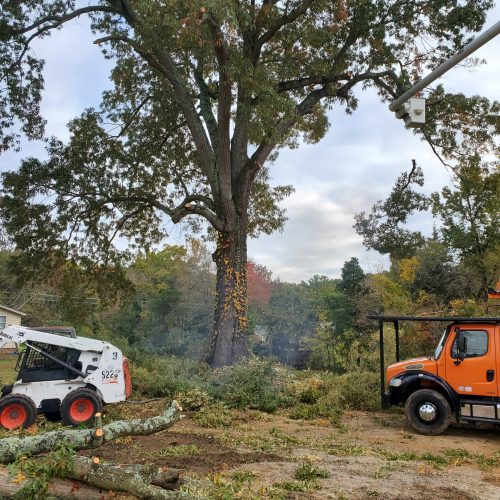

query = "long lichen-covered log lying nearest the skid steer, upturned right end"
(0, 401), (182, 464)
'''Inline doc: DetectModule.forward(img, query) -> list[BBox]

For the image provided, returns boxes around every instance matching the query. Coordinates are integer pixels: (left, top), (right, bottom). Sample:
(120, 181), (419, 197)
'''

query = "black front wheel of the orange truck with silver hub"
(405, 389), (451, 436)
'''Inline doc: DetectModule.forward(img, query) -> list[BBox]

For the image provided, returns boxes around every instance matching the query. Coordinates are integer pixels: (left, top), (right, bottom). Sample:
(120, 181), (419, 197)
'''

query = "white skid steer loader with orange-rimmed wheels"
(0, 326), (132, 429)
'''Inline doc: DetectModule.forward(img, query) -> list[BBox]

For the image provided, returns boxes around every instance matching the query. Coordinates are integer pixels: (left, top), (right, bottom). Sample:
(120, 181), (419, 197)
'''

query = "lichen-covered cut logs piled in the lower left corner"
(0, 401), (197, 500)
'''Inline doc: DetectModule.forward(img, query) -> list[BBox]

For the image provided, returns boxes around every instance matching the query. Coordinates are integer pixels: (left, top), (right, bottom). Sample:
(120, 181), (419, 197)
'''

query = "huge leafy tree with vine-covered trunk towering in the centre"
(0, 0), (493, 365)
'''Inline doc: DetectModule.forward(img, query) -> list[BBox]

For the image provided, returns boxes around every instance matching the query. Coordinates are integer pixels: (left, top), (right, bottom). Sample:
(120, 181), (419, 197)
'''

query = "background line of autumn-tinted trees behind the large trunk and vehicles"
(0, 157), (500, 372)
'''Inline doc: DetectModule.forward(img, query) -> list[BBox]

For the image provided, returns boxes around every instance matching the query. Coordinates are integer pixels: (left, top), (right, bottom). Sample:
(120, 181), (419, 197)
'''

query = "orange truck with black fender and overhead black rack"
(369, 316), (500, 435)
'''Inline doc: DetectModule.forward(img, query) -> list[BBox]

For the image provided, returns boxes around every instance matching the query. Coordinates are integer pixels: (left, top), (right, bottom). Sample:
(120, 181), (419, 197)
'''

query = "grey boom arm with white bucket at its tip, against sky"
(389, 21), (500, 128)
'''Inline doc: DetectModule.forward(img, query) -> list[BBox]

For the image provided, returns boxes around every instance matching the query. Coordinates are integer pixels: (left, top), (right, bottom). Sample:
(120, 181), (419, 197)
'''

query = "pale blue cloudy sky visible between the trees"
(0, 3), (500, 282)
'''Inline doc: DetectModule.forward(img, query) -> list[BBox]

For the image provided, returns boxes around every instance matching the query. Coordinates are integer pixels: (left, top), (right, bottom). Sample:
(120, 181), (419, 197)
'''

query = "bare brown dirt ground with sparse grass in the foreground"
(80, 404), (500, 500)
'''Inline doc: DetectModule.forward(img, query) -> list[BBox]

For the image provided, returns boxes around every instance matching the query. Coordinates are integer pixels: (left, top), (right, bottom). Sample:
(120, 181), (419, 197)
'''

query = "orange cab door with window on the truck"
(446, 325), (499, 396)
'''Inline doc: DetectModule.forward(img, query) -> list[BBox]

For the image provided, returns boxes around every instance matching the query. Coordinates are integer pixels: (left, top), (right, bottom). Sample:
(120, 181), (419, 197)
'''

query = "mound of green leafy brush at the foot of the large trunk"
(209, 359), (285, 412)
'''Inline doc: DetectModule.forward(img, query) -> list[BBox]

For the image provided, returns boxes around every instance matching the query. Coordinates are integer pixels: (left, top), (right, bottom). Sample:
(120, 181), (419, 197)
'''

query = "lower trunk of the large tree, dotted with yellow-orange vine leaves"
(208, 221), (248, 367)
